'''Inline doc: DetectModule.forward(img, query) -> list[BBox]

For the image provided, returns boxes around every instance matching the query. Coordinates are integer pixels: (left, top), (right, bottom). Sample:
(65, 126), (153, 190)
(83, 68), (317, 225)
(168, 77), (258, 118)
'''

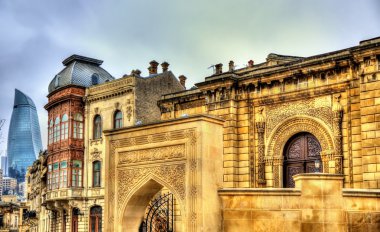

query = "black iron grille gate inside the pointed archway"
(139, 193), (174, 232)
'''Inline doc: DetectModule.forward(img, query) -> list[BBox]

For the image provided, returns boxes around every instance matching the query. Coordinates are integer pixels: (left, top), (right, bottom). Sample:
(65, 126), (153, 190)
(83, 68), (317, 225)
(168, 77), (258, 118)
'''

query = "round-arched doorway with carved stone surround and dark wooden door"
(265, 115), (336, 187)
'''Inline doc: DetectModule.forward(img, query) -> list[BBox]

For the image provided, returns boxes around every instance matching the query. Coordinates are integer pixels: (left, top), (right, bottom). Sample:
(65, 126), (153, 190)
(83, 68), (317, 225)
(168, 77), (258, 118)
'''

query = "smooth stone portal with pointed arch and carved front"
(104, 116), (223, 232)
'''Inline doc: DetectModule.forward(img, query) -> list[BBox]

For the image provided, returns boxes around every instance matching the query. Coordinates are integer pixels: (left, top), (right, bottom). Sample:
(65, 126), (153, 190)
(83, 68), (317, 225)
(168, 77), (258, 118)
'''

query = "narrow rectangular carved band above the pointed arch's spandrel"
(119, 144), (185, 164)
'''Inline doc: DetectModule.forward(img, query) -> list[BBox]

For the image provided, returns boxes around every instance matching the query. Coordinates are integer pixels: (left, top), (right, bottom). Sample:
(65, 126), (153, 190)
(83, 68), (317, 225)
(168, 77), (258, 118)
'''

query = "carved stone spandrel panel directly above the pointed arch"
(117, 163), (186, 210)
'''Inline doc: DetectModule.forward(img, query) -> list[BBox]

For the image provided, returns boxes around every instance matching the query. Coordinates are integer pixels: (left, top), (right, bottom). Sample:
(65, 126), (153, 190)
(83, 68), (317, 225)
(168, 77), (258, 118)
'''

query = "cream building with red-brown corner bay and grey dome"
(39, 55), (184, 231)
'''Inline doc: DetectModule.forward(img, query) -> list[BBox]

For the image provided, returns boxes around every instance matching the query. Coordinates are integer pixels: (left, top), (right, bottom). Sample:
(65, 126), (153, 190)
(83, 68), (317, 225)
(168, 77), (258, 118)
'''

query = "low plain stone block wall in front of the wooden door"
(219, 173), (380, 232)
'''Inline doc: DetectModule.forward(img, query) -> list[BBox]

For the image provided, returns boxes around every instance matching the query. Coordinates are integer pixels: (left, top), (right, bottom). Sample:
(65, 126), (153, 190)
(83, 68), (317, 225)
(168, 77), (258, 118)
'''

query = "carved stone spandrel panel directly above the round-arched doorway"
(266, 96), (333, 137)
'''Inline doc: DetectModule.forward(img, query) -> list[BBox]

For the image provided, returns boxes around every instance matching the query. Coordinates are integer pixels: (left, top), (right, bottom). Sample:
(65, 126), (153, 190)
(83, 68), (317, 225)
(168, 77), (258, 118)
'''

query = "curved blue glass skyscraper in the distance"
(8, 89), (42, 182)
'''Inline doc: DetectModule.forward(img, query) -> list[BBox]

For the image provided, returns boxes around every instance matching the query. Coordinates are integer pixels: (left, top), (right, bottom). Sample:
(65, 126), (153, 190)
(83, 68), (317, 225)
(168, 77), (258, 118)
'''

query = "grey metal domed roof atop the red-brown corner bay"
(49, 55), (115, 93)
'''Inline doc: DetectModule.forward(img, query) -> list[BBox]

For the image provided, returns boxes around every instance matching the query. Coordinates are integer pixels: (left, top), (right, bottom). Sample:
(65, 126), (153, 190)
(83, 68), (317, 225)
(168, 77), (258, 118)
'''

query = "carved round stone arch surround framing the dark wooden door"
(265, 115), (335, 187)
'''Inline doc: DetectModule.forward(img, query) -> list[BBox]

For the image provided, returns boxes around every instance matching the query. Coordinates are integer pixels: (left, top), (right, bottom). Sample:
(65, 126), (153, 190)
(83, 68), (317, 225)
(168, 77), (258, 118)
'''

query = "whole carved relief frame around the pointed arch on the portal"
(107, 129), (200, 231)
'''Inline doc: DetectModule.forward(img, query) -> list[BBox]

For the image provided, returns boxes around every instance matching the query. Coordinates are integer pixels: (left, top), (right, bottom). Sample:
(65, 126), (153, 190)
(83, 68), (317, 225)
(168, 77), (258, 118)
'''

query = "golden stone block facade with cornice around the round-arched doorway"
(159, 35), (380, 188)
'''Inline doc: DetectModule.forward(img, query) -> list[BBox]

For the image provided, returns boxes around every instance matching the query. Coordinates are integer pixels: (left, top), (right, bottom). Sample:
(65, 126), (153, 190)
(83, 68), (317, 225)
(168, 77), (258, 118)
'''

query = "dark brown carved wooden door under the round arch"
(284, 133), (321, 188)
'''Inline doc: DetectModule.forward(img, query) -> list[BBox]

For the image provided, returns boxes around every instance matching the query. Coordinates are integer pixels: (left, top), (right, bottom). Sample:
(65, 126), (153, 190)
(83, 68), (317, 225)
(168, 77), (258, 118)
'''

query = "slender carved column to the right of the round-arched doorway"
(332, 94), (343, 174)
